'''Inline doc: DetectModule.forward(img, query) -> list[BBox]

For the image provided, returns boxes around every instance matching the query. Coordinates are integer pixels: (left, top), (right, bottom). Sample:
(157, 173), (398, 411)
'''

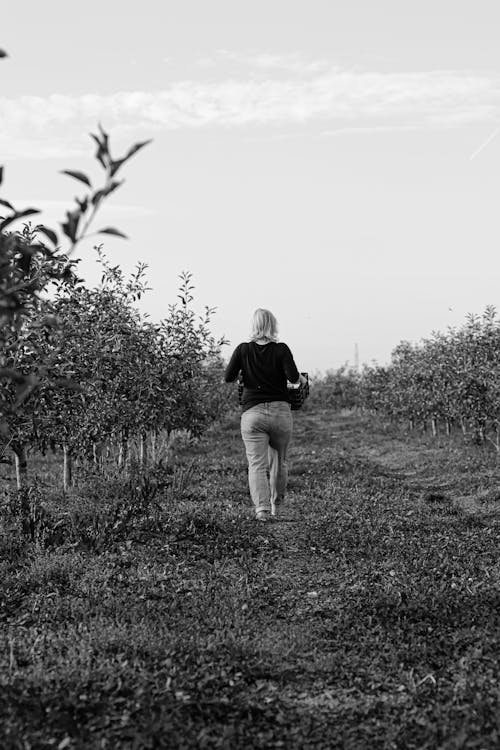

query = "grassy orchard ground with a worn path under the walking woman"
(0, 404), (500, 750)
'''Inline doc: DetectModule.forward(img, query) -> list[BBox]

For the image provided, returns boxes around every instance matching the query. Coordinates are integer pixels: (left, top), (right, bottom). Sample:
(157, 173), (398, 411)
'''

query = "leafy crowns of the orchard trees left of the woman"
(0, 248), (228, 484)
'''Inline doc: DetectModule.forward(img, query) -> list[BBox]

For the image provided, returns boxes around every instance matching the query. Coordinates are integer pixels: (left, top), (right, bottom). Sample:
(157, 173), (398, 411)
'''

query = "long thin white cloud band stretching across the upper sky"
(0, 65), (500, 156)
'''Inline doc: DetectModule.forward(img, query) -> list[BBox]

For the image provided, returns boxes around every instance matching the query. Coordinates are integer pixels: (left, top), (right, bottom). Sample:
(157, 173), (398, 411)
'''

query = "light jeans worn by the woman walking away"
(241, 401), (293, 514)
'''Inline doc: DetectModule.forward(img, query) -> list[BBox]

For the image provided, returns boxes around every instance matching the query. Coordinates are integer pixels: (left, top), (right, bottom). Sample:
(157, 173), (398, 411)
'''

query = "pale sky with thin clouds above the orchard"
(0, 0), (500, 372)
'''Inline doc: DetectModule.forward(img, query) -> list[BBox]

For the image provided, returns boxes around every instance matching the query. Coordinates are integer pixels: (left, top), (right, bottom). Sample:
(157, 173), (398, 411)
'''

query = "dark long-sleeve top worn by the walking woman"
(224, 341), (300, 411)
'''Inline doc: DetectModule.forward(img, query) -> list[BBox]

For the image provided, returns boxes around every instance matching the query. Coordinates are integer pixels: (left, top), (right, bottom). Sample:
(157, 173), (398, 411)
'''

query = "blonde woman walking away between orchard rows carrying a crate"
(225, 308), (304, 521)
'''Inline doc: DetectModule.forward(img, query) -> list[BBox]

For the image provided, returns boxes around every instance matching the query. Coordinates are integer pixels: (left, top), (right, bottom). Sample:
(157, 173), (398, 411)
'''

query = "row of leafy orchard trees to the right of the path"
(316, 307), (500, 451)
